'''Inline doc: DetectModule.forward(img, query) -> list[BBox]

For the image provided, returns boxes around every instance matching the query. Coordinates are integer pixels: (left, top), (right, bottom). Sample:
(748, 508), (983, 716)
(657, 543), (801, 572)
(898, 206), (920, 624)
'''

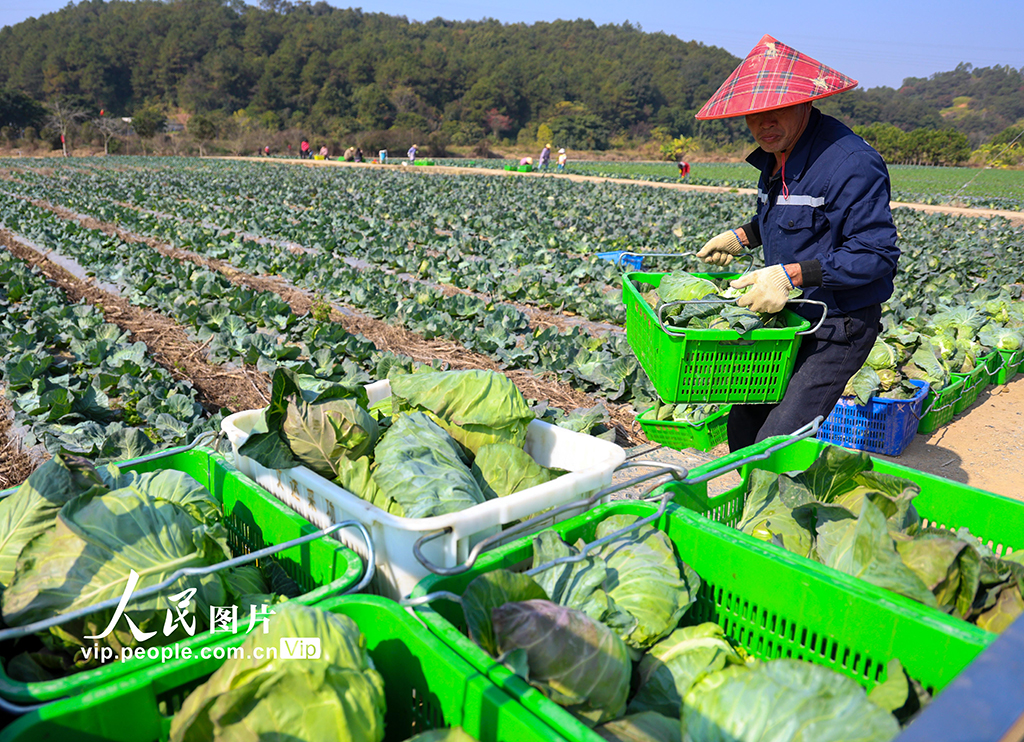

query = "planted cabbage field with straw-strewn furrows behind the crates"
(0, 158), (1024, 476)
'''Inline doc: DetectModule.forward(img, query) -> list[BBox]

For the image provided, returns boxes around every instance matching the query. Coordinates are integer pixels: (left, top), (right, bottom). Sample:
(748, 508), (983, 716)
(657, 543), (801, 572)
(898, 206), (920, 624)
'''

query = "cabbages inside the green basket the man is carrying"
(635, 272), (802, 333)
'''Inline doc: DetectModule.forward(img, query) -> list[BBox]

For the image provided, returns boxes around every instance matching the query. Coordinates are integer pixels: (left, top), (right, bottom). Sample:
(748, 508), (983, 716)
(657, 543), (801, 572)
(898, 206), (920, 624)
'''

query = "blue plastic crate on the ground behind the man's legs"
(818, 380), (928, 456)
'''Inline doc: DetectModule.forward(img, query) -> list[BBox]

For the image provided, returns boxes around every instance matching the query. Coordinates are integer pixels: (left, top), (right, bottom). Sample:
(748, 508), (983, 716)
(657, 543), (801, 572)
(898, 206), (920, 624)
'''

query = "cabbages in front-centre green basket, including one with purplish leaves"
(462, 515), (913, 742)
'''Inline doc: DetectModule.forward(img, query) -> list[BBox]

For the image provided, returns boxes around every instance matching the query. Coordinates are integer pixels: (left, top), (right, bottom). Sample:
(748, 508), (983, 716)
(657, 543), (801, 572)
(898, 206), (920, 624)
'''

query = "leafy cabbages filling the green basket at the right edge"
(736, 446), (1024, 632)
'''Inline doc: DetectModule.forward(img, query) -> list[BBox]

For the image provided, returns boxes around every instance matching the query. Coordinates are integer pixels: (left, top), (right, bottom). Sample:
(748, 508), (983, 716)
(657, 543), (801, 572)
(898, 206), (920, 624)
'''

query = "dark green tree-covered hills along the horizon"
(0, 0), (1024, 162)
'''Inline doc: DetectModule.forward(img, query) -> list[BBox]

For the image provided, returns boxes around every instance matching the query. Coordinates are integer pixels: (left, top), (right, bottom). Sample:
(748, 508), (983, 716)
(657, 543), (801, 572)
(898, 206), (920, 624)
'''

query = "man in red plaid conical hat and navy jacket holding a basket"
(696, 35), (900, 450)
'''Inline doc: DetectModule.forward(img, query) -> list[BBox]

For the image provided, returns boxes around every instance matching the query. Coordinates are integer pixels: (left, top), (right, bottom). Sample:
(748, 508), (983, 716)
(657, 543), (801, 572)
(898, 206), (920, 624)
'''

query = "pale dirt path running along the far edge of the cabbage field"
(232, 158), (1024, 224)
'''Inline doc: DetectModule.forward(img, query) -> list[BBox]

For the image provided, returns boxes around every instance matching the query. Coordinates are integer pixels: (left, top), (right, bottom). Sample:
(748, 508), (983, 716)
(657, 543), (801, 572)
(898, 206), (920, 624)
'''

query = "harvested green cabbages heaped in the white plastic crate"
(239, 367), (564, 518)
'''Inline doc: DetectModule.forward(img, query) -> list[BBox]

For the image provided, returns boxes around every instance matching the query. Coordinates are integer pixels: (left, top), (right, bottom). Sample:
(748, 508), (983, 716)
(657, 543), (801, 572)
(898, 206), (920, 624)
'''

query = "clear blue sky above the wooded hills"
(0, 0), (1024, 87)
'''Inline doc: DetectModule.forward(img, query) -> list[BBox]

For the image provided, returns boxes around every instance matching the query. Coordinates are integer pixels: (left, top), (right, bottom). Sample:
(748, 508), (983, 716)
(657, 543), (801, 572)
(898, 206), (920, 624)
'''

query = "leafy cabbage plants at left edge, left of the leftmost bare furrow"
(0, 245), (212, 459)
